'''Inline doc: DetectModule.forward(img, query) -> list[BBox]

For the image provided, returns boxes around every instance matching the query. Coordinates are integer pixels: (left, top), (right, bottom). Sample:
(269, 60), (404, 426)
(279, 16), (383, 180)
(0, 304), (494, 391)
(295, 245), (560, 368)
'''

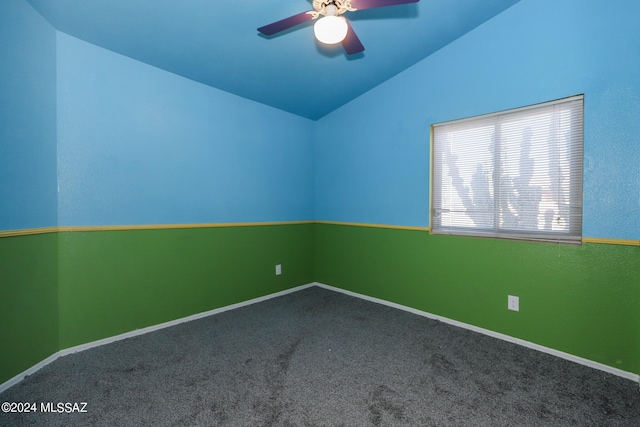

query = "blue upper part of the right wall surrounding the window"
(316, 0), (640, 240)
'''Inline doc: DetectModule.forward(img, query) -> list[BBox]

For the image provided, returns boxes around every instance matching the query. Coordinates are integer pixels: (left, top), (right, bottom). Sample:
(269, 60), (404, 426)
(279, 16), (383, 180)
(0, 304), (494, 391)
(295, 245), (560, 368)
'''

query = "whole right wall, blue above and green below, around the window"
(316, 0), (640, 373)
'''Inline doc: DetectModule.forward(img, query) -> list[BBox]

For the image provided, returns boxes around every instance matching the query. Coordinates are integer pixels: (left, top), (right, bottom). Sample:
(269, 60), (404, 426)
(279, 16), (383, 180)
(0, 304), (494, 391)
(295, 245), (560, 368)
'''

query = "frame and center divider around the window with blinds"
(429, 94), (584, 244)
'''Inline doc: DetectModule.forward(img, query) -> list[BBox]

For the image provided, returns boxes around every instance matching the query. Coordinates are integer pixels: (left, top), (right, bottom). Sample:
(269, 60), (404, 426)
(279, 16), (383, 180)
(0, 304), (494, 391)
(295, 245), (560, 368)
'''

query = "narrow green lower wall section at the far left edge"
(0, 233), (59, 384)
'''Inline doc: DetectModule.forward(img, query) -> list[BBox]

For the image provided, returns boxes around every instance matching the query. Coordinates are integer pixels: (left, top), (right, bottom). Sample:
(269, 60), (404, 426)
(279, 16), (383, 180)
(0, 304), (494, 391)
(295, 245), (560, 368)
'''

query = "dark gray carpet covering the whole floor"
(0, 287), (640, 427)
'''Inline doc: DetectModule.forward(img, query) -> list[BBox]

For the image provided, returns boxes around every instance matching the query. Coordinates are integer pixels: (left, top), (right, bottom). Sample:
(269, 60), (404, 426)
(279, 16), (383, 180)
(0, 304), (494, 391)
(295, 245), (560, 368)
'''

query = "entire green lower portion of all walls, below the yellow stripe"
(0, 224), (640, 383)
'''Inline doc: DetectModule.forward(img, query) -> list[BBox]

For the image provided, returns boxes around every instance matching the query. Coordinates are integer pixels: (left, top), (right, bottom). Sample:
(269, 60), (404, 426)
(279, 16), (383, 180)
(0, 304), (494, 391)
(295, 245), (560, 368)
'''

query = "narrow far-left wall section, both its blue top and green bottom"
(0, 0), (59, 384)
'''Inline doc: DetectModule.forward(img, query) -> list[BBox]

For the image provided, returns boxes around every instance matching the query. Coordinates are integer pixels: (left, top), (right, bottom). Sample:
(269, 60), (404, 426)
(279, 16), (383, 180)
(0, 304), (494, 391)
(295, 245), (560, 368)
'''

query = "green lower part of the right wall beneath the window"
(315, 224), (640, 374)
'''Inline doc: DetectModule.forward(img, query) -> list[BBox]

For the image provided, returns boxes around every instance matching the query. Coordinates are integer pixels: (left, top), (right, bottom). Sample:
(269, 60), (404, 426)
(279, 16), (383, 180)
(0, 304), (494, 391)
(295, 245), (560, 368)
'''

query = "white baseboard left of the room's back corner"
(0, 283), (315, 393)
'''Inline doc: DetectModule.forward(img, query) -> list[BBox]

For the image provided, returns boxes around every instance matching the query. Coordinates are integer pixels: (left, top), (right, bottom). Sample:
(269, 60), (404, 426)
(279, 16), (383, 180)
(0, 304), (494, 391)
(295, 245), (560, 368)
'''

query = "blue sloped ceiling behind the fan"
(27, 0), (520, 120)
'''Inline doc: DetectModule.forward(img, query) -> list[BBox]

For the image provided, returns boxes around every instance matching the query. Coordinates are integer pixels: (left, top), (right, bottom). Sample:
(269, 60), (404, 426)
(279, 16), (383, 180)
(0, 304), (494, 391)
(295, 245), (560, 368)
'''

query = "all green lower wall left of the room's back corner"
(0, 223), (314, 384)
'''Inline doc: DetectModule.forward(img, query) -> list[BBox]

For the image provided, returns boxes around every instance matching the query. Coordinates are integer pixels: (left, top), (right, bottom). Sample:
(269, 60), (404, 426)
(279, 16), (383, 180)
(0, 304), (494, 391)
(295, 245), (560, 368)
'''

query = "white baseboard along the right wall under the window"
(314, 282), (640, 382)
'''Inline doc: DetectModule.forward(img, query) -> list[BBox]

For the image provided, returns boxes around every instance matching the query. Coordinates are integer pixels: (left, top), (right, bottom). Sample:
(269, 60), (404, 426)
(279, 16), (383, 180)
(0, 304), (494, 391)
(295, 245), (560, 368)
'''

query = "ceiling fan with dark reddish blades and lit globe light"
(258, 0), (420, 55)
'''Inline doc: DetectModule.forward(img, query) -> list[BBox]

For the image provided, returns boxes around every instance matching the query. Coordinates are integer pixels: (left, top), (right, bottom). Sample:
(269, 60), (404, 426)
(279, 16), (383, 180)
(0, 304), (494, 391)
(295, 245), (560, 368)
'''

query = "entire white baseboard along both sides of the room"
(0, 282), (640, 393)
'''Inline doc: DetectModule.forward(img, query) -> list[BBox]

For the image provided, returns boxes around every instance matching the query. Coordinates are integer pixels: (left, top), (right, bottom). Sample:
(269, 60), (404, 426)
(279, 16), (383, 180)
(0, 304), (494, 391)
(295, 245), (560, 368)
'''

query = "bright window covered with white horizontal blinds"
(431, 96), (584, 243)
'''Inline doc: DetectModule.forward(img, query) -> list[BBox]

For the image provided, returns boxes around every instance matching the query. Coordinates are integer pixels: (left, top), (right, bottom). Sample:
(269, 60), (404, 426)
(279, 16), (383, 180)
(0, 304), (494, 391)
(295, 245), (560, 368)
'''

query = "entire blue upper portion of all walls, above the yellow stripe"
(7, 0), (640, 239)
